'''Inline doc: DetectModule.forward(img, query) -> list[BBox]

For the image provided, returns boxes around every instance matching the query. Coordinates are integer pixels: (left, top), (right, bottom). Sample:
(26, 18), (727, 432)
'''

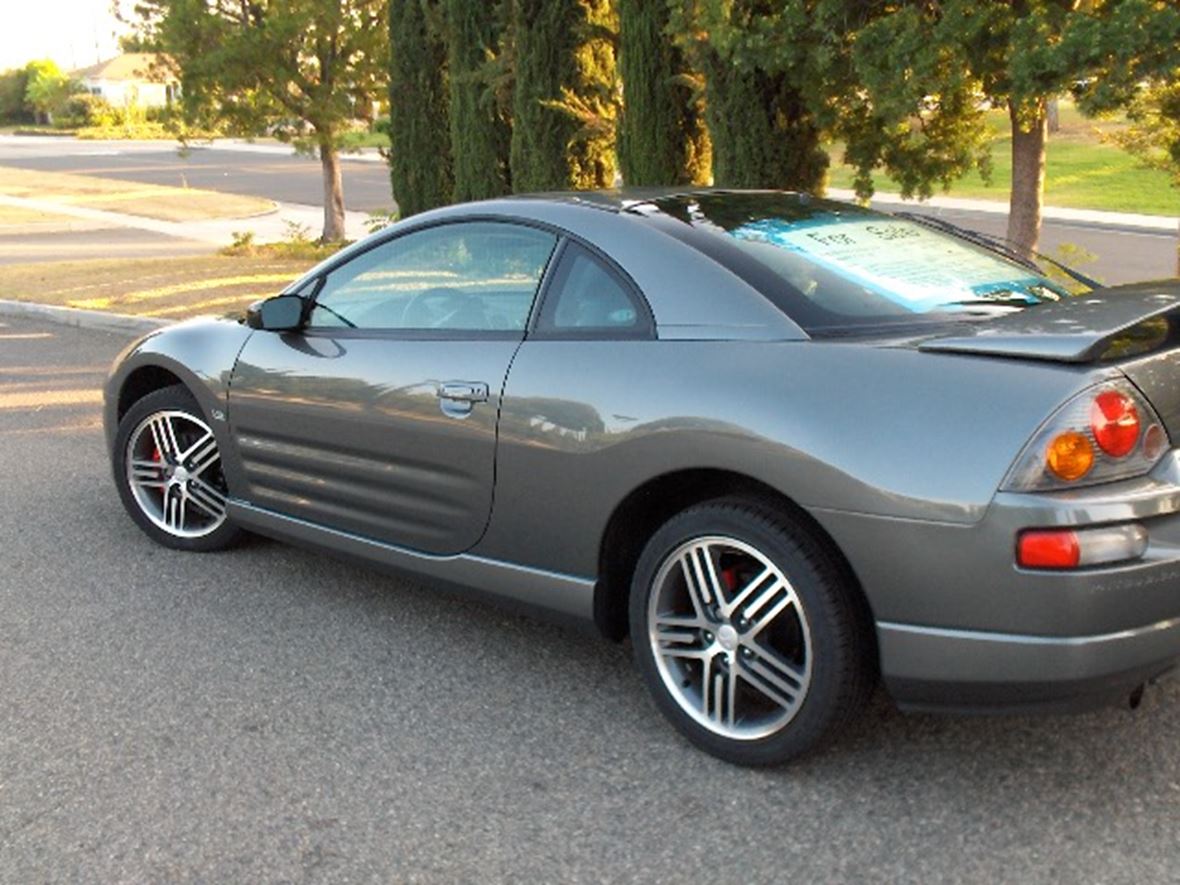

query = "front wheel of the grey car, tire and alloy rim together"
(111, 385), (242, 552)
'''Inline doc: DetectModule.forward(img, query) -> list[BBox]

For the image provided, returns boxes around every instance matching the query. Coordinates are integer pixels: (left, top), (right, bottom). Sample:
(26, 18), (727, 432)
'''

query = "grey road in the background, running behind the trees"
(0, 137), (1180, 284)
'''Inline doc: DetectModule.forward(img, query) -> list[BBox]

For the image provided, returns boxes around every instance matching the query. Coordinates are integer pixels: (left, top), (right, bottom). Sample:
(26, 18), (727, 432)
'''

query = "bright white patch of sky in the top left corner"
(0, 0), (130, 71)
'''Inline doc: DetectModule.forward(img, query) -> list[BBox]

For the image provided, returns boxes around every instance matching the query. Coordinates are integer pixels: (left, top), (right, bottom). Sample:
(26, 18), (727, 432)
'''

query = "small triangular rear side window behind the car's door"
(537, 242), (651, 337)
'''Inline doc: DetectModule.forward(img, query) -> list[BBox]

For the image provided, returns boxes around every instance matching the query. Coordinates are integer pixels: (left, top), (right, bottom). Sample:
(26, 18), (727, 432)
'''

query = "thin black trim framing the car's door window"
(302, 214), (566, 341)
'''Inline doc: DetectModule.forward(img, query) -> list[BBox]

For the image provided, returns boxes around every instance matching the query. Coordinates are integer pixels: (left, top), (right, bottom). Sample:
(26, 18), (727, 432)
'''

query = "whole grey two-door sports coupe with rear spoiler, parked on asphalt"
(105, 191), (1180, 765)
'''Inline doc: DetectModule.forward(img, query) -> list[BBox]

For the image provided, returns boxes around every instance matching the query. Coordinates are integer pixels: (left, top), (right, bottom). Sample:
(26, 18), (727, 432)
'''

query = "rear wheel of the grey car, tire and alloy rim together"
(629, 499), (876, 766)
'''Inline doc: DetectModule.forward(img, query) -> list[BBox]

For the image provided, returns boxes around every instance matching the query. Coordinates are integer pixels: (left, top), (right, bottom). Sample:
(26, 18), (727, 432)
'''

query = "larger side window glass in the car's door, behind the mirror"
(310, 222), (557, 332)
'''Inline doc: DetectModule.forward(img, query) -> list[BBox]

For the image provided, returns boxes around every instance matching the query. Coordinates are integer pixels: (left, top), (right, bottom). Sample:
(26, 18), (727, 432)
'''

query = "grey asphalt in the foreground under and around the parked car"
(0, 317), (1180, 883)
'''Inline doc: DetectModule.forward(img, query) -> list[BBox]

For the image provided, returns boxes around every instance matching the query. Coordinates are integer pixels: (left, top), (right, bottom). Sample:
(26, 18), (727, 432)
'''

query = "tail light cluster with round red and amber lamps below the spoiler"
(1001, 381), (1171, 492)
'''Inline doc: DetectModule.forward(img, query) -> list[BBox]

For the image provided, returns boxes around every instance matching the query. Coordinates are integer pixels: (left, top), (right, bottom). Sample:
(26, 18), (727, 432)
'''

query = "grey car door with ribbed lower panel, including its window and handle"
(228, 221), (557, 553)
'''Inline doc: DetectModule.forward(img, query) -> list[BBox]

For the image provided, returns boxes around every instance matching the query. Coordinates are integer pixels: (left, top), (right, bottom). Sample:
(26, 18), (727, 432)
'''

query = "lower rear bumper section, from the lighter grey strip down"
(877, 617), (1180, 712)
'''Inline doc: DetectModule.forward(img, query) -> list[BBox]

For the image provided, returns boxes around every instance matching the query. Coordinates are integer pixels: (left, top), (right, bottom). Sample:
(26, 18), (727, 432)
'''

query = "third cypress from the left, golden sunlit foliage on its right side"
(510, 0), (617, 191)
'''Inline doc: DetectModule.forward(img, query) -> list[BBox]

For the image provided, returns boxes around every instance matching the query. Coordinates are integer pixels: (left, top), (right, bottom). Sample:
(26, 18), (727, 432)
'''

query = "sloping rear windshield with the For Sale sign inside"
(632, 192), (1068, 334)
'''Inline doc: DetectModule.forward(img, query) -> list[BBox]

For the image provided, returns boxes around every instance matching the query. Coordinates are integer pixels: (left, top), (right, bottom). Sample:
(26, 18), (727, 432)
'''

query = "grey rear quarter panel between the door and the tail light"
(479, 341), (1093, 575)
